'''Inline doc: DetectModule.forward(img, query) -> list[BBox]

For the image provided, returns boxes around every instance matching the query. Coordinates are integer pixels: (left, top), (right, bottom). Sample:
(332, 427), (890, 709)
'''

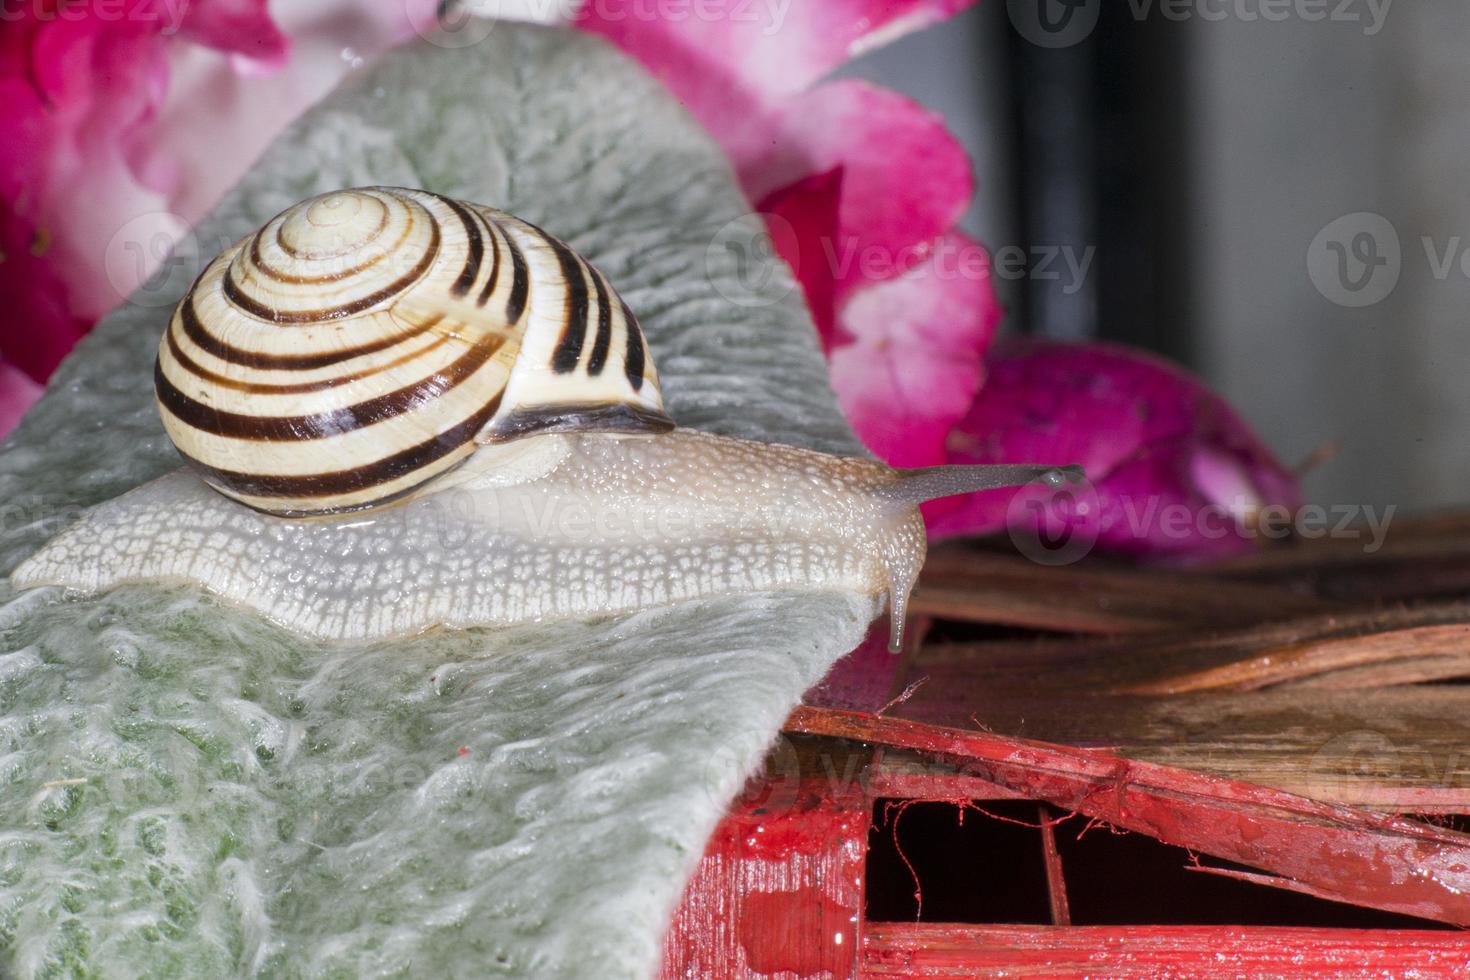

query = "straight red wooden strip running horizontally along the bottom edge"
(858, 923), (1470, 980)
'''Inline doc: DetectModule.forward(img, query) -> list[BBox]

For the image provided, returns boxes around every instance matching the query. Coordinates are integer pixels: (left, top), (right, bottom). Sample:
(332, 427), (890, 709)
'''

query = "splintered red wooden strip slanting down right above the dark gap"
(786, 708), (1470, 926)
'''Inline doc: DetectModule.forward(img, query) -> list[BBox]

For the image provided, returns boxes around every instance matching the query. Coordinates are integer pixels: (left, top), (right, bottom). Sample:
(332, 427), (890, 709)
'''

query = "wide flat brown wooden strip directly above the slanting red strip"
(875, 674), (1470, 813)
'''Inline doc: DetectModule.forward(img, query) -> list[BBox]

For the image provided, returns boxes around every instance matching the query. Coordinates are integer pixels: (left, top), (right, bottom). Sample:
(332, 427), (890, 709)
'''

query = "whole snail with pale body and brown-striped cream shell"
(12, 187), (1066, 648)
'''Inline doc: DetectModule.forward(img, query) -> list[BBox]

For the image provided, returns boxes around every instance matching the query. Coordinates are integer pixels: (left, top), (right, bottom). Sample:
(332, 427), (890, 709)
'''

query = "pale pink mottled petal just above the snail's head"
(832, 234), (1001, 466)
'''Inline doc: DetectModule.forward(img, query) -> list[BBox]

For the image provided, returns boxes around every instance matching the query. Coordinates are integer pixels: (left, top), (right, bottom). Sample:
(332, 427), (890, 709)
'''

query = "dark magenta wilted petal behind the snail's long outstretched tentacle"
(931, 341), (1301, 558)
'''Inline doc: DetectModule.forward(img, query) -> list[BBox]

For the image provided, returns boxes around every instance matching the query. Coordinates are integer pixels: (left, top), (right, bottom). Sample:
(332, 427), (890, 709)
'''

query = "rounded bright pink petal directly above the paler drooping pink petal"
(736, 81), (975, 300)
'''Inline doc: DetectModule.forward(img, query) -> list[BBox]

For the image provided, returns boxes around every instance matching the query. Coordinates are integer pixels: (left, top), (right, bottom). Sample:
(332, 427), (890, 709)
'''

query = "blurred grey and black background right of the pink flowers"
(842, 0), (1470, 510)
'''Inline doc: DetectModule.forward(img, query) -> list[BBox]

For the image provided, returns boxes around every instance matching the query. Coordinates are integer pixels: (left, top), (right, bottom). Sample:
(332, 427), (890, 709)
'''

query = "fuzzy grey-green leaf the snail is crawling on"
(0, 24), (873, 977)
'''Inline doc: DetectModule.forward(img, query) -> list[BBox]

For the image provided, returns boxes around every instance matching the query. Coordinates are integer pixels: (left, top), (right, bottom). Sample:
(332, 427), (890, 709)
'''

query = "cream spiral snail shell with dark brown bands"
(154, 187), (673, 516)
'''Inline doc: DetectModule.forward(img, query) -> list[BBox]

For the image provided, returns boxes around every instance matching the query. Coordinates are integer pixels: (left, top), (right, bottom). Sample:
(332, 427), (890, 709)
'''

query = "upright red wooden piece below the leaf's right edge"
(660, 780), (872, 980)
